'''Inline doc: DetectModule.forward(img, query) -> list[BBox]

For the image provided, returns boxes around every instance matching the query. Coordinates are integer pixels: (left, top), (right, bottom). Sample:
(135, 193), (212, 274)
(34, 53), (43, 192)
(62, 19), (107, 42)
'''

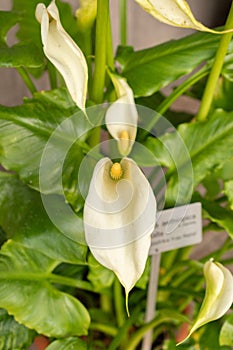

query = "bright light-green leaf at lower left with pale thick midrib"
(0, 241), (90, 337)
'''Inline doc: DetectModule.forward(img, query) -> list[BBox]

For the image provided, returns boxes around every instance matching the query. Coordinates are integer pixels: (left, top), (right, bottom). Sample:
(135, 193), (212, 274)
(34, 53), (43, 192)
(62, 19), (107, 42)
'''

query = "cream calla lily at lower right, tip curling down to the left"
(178, 259), (233, 345)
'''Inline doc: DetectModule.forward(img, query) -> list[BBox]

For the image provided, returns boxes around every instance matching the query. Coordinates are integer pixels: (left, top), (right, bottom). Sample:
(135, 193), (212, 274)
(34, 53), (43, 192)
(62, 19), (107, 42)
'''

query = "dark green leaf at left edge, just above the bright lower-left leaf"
(0, 172), (87, 264)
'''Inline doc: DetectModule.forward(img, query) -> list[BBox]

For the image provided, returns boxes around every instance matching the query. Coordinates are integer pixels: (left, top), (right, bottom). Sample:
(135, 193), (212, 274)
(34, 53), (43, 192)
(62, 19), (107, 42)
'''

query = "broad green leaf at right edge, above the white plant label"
(146, 110), (233, 205)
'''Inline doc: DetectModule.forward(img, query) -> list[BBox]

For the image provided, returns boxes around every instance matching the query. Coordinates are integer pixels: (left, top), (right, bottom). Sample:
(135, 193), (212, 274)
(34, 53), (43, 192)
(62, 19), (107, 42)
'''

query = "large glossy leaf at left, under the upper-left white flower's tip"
(0, 89), (90, 202)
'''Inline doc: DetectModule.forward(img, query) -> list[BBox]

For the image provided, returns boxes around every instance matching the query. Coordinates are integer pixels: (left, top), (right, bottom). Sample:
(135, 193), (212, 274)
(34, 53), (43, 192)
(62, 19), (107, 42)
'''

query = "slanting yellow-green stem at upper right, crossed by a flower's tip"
(197, 3), (233, 121)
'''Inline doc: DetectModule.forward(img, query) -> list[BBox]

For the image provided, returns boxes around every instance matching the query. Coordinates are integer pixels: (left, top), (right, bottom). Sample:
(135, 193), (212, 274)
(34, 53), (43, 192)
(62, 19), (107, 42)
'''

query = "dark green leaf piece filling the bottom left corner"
(0, 309), (35, 350)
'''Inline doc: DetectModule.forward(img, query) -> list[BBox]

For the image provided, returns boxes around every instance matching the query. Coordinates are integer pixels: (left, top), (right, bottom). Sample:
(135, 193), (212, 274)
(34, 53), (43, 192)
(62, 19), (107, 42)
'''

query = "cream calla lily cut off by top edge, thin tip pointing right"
(135, 0), (233, 34)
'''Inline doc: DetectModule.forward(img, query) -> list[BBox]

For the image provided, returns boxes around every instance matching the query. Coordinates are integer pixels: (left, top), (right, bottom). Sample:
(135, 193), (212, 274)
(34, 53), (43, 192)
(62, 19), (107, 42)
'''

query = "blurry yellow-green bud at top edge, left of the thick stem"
(75, 0), (97, 31)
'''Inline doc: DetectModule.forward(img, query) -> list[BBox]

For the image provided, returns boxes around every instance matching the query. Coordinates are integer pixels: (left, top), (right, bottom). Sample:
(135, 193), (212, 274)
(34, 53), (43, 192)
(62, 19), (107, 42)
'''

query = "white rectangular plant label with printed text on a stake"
(149, 203), (202, 255)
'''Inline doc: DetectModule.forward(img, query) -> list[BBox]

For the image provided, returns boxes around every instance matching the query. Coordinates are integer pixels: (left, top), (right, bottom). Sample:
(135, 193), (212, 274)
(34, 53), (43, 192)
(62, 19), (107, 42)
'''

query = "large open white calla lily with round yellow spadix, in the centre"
(84, 158), (156, 297)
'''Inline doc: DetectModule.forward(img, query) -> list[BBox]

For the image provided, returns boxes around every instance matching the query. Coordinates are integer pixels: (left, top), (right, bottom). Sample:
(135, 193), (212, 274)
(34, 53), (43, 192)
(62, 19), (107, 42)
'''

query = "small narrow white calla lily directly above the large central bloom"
(106, 74), (138, 156)
